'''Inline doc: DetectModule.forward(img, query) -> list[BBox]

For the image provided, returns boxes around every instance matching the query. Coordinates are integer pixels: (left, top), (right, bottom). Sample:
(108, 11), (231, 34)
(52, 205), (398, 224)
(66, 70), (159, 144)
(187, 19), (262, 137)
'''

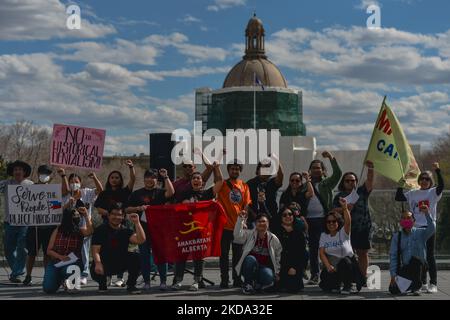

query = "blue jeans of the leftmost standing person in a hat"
(4, 222), (28, 278)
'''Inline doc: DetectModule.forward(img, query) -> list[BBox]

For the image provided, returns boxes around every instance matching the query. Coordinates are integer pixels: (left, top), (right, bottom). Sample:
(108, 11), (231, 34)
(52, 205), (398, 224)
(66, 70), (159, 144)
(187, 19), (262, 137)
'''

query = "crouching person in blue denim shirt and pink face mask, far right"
(389, 209), (436, 296)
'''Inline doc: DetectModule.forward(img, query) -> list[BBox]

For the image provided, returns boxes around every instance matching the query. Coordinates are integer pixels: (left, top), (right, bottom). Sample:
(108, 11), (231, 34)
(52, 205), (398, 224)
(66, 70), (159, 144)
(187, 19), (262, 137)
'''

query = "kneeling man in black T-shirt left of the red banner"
(91, 205), (145, 294)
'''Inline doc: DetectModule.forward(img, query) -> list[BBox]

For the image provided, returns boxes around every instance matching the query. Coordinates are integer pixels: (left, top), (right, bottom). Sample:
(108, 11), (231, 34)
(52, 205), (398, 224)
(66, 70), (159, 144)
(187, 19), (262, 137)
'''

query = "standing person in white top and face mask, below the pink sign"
(58, 168), (103, 285)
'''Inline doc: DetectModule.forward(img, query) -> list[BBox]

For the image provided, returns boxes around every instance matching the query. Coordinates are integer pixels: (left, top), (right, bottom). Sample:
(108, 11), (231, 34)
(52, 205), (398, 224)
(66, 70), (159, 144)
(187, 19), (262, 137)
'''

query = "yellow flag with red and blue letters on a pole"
(364, 97), (420, 189)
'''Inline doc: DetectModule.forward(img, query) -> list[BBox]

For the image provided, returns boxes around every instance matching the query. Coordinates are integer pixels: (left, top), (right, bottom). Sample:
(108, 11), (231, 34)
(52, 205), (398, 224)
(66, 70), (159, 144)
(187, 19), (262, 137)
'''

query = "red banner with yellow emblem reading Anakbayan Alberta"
(145, 201), (227, 264)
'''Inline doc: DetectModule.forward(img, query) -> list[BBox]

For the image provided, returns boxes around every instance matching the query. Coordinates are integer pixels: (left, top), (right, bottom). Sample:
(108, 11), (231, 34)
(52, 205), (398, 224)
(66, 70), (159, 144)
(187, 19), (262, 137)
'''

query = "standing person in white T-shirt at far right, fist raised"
(395, 162), (444, 293)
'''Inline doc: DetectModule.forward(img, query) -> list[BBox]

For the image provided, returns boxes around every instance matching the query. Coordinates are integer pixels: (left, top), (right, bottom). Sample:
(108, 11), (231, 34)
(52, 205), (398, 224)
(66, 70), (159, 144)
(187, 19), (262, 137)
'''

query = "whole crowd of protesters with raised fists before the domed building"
(0, 151), (444, 295)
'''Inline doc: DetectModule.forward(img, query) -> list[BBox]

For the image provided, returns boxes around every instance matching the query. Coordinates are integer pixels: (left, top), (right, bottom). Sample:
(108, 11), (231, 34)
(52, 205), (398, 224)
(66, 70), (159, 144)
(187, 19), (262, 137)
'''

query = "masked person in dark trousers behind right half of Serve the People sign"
(23, 165), (56, 286)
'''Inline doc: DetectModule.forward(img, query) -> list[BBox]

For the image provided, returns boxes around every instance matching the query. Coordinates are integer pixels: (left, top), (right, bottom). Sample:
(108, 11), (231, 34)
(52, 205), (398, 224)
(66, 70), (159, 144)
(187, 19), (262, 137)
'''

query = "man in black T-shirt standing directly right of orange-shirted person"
(247, 155), (284, 228)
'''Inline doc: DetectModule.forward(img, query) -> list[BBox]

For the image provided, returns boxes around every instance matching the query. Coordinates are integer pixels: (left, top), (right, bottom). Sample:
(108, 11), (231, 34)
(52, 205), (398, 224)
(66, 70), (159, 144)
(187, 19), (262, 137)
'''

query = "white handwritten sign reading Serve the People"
(8, 184), (62, 226)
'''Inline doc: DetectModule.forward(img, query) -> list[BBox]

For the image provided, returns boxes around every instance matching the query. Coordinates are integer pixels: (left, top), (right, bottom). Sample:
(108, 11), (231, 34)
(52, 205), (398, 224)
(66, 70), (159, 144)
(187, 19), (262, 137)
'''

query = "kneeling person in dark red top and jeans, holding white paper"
(42, 207), (94, 294)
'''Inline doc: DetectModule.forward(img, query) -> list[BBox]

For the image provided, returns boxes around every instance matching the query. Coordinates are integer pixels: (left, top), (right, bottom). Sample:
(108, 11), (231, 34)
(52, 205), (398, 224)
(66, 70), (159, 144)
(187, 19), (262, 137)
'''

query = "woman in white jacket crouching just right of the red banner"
(233, 211), (282, 294)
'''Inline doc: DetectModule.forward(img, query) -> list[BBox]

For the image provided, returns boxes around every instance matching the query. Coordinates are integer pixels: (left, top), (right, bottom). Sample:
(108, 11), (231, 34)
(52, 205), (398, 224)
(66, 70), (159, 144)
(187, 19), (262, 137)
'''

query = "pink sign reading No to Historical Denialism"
(50, 124), (105, 171)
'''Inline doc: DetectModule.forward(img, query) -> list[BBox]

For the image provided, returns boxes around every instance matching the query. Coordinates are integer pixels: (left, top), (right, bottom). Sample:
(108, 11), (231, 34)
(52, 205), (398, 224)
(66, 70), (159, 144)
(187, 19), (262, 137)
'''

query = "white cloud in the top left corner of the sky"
(0, 0), (116, 40)
